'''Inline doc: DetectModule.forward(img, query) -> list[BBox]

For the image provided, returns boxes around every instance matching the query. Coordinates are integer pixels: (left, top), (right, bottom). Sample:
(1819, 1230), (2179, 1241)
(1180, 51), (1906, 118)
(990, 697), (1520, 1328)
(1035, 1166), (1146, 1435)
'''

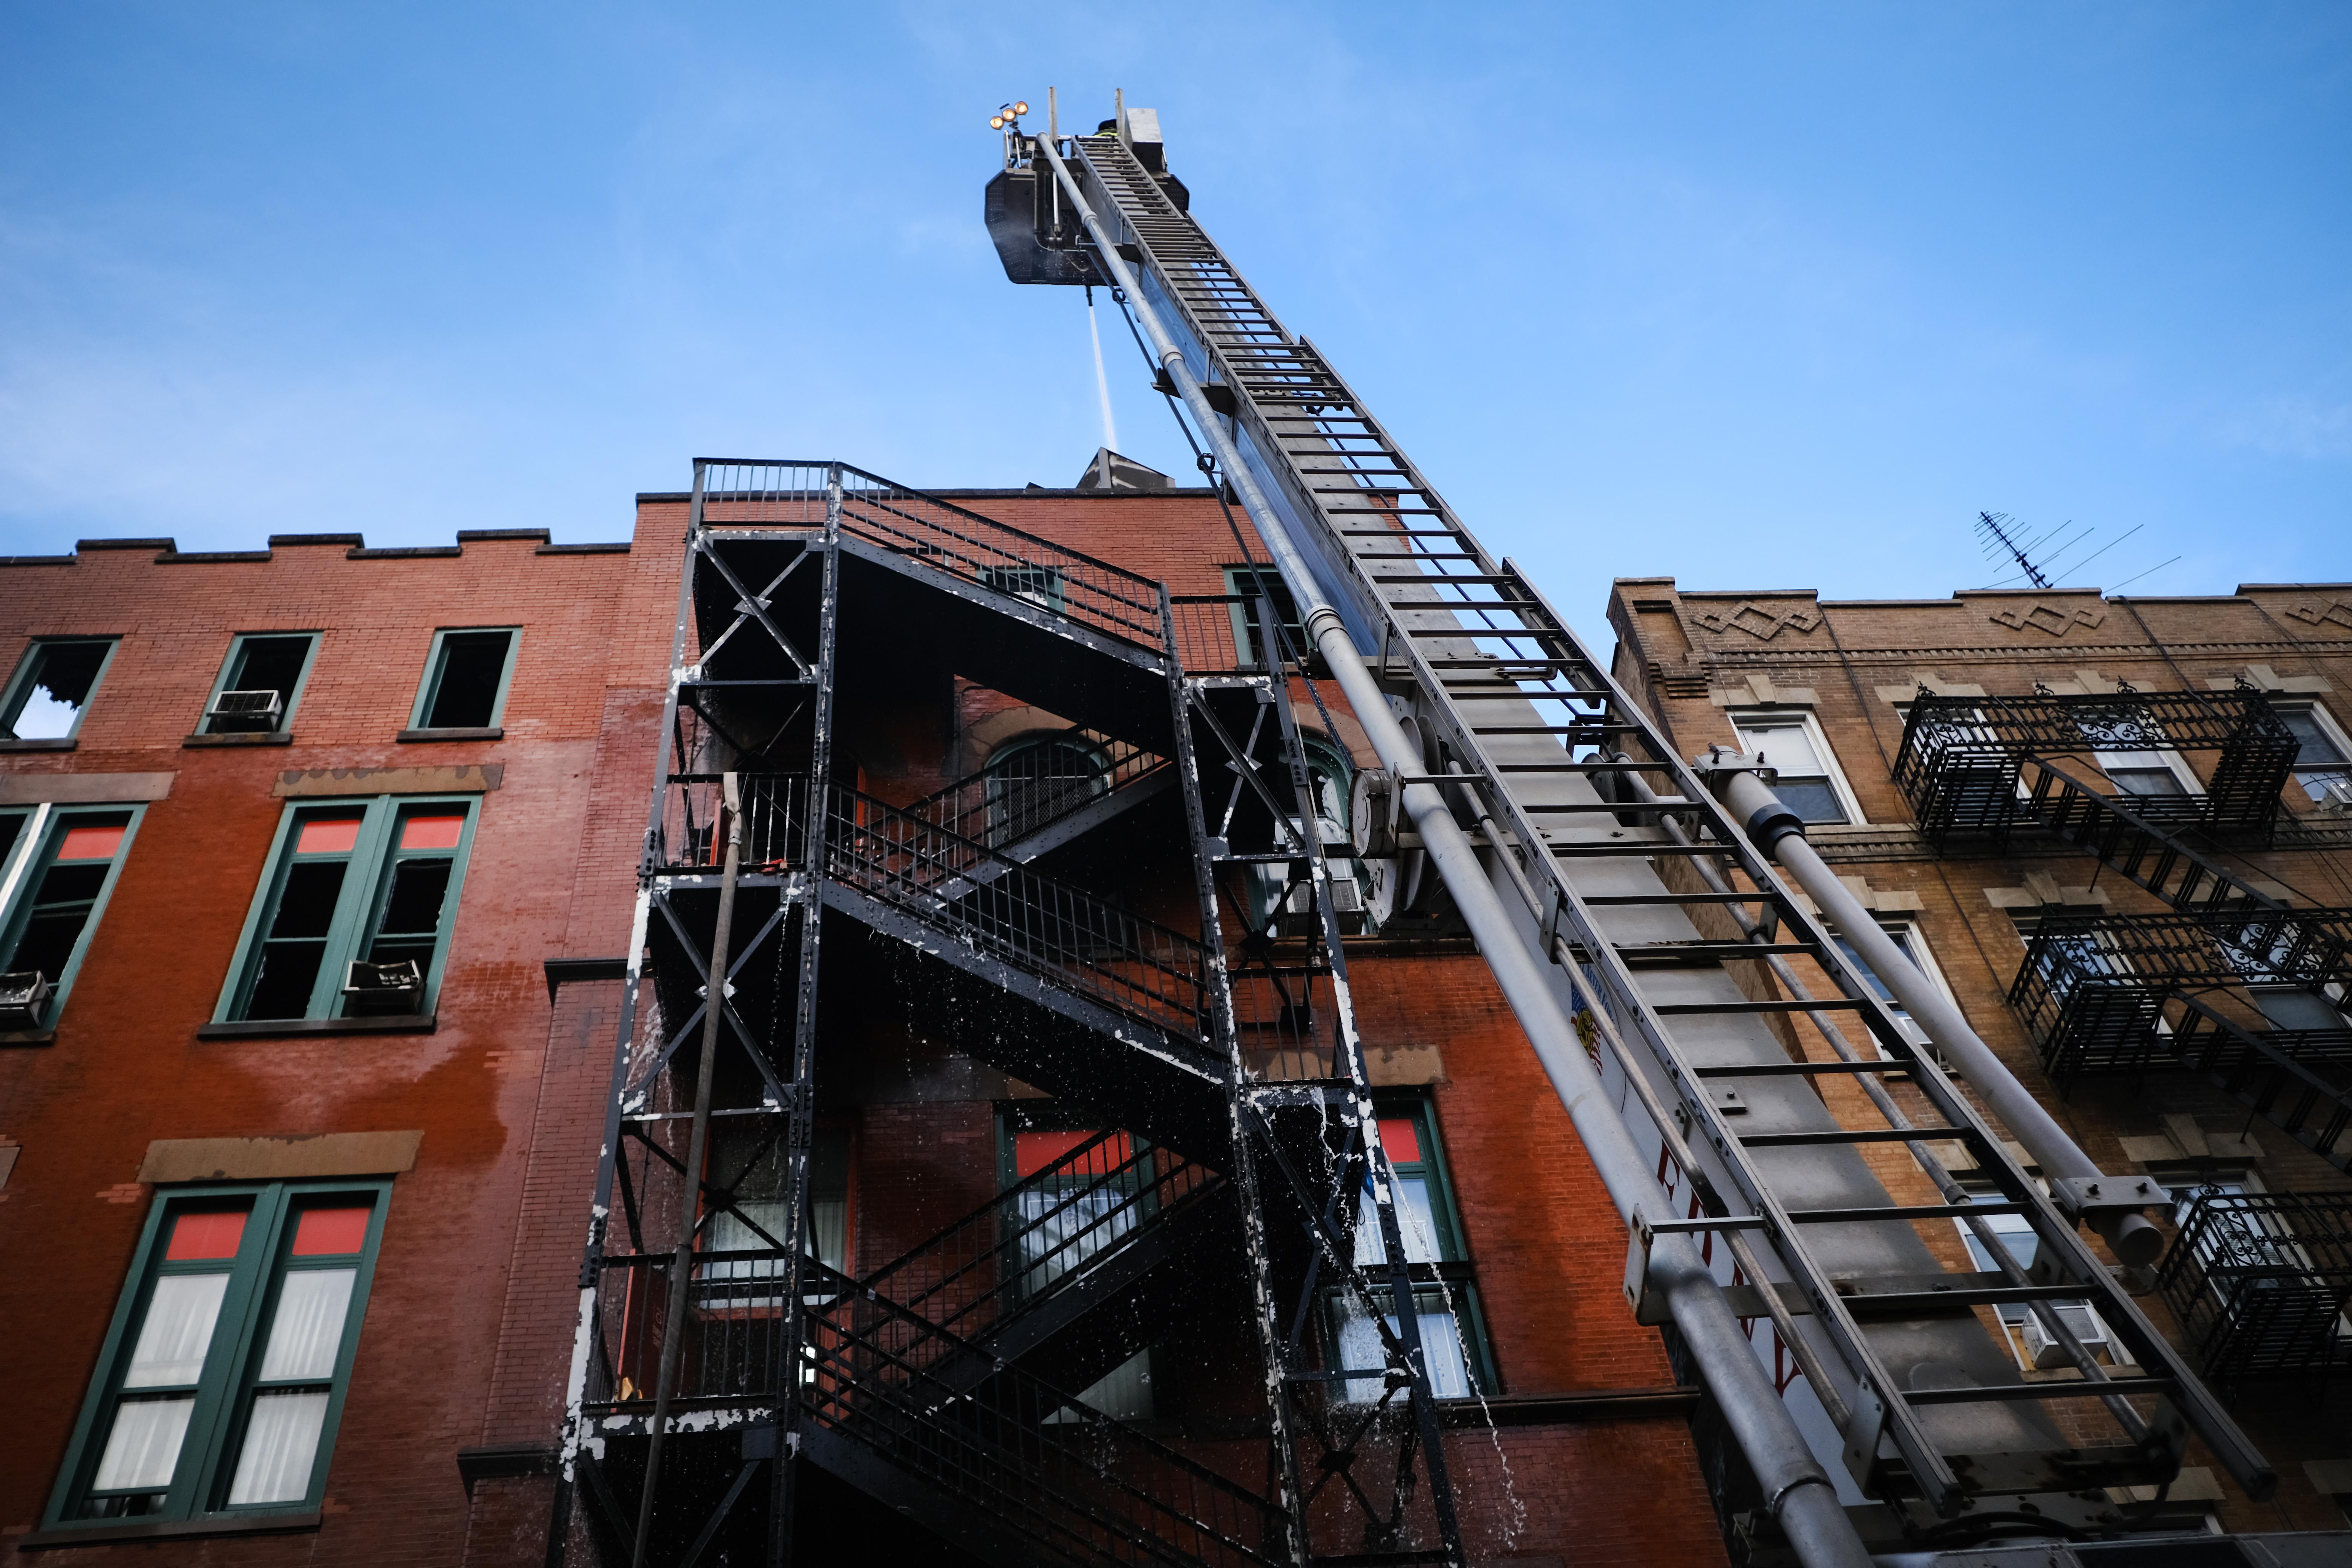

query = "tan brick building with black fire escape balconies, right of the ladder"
(1609, 578), (2352, 1530)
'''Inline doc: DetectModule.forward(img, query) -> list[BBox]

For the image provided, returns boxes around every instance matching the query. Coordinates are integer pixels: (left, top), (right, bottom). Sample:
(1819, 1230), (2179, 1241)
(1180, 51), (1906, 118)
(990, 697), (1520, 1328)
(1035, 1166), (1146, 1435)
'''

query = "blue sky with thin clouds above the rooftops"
(0, 0), (2352, 639)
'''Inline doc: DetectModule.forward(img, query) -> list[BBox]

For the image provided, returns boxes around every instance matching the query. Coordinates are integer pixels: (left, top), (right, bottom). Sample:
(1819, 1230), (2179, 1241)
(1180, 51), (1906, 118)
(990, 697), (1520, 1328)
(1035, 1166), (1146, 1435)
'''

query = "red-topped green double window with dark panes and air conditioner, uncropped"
(219, 795), (478, 1023)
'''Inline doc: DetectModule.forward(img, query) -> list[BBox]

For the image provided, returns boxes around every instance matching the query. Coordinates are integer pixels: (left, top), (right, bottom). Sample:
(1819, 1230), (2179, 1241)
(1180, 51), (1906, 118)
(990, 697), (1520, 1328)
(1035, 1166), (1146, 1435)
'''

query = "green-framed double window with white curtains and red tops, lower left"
(45, 1180), (390, 1528)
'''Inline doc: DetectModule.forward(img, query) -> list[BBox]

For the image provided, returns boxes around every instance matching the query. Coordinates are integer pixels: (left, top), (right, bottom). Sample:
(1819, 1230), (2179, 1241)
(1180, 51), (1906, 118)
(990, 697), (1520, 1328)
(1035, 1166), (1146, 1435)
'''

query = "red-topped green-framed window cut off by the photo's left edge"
(0, 806), (141, 1030)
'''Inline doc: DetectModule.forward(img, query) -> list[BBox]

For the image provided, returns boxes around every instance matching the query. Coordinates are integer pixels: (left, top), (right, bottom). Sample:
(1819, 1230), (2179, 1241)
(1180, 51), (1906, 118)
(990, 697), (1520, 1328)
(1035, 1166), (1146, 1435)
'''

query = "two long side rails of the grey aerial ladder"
(1072, 139), (2265, 1505)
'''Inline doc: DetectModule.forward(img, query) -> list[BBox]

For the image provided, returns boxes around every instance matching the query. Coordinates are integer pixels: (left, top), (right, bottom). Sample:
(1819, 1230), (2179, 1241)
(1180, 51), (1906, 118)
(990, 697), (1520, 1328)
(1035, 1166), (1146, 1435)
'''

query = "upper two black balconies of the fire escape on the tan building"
(1896, 689), (2352, 1168)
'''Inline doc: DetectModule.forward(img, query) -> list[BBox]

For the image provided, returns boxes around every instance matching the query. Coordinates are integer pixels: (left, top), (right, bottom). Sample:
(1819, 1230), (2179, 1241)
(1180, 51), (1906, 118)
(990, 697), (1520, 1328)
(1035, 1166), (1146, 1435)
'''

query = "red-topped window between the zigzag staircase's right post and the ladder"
(1324, 1095), (1501, 1403)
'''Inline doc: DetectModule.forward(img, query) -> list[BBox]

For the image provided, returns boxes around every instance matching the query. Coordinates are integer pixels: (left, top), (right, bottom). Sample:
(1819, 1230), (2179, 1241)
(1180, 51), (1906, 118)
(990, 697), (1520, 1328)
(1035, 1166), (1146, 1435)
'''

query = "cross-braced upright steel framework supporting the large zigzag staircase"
(548, 461), (1463, 1566)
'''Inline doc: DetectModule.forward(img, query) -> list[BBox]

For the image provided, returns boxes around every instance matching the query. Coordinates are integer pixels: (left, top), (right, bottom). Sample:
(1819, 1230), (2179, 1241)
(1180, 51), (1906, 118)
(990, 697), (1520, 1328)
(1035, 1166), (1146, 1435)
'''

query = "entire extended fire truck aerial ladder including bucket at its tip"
(988, 92), (2274, 1563)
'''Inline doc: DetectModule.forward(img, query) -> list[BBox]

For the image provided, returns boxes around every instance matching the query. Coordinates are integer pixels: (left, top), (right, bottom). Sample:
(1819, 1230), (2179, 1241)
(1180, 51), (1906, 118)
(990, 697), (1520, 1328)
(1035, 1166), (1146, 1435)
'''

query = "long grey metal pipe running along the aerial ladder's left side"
(1037, 141), (1870, 1568)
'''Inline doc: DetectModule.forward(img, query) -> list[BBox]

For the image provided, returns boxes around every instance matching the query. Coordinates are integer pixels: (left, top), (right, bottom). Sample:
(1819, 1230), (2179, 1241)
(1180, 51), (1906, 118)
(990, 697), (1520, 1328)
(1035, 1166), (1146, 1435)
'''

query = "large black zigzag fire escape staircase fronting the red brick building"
(548, 461), (1461, 1566)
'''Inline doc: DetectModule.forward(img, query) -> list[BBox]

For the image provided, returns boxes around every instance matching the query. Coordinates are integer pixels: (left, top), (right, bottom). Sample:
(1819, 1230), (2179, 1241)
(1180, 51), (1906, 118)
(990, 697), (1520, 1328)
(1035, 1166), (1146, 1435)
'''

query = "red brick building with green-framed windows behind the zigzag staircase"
(0, 489), (1724, 1563)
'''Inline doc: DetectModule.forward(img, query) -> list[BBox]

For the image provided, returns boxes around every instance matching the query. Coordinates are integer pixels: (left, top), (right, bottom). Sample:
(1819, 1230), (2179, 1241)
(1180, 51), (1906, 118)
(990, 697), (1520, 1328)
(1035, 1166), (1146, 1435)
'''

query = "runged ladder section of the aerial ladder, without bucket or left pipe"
(1054, 136), (2274, 1533)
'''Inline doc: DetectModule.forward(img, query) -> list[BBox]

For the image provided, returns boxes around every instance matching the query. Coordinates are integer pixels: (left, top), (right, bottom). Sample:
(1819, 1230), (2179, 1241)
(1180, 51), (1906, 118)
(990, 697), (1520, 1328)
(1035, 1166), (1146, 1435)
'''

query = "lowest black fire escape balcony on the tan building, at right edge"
(2157, 1187), (2352, 1382)
